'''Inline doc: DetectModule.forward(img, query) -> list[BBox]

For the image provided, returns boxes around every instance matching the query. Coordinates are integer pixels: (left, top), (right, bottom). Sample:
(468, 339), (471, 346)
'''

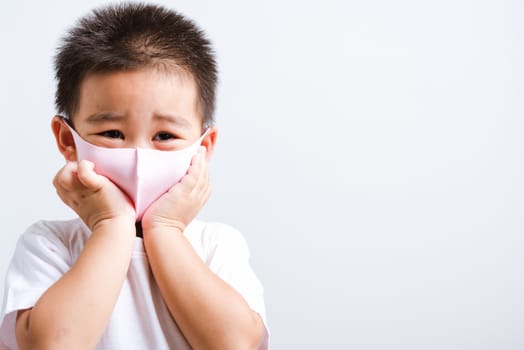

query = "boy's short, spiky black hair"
(55, 3), (218, 125)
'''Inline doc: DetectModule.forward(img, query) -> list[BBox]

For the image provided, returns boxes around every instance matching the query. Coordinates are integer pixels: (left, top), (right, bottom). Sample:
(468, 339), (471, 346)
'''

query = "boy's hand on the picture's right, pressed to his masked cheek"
(142, 147), (211, 232)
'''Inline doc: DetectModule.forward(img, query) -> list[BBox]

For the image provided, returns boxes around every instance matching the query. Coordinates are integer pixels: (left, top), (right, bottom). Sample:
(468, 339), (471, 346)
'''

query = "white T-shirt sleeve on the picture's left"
(0, 222), (71, 349)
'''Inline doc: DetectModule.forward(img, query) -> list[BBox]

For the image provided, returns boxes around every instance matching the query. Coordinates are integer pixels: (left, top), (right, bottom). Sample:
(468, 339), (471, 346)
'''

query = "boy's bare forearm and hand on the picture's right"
(142, 151), (264, 350)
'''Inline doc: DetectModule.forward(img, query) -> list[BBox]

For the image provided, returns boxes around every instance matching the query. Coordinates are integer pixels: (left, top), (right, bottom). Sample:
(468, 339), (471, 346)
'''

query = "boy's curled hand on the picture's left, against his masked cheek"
(53, 160), (136, 230)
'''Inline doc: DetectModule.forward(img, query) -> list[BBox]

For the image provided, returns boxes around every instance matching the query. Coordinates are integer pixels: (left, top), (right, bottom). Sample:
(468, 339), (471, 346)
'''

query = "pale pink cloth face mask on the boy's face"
(69, 126), (207, 221)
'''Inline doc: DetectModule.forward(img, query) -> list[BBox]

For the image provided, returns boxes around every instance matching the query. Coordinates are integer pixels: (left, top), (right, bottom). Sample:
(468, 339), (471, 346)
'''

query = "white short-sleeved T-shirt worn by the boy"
(0, 219), (268, 350)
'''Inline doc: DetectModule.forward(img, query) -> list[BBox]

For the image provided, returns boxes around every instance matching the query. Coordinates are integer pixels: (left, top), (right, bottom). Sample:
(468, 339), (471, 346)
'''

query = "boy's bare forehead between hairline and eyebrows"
(72, 67), (202, 124)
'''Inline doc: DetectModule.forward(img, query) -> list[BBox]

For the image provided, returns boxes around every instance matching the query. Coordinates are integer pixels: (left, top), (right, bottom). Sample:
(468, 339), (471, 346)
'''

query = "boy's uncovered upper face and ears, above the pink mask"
(52, 68), (216, 160)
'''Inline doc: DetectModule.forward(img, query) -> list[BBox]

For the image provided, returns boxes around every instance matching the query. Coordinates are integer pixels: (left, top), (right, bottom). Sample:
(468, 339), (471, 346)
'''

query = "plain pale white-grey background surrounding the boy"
(0, 0), (524, 350)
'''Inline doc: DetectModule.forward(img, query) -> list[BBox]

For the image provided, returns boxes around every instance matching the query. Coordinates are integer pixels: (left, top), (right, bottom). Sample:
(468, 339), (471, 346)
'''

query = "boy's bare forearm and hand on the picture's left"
(16, 162), (135, 349)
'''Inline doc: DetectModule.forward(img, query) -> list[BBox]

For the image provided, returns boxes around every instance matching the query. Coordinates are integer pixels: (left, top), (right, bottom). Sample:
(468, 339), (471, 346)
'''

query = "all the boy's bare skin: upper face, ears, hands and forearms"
(16, 68), (264, 350)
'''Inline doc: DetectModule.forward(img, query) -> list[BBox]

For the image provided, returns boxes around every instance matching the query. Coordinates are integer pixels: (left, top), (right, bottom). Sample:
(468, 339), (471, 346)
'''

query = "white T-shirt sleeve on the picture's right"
(202, 224), (269, 350)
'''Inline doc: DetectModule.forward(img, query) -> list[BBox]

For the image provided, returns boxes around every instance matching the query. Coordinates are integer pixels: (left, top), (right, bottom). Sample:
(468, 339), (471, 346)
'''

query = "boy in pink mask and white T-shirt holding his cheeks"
(0, 4), (268, 350)
